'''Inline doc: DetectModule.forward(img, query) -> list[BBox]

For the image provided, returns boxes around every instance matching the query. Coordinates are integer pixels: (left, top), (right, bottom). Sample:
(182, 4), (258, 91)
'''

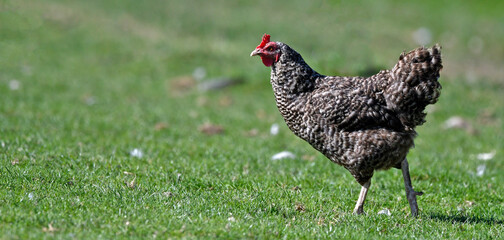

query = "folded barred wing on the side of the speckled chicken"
(306, 77), (404, 131)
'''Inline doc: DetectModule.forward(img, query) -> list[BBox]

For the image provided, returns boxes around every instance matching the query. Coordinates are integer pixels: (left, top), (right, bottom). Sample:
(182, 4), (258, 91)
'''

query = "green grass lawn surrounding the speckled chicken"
(0, 0), (504, 239)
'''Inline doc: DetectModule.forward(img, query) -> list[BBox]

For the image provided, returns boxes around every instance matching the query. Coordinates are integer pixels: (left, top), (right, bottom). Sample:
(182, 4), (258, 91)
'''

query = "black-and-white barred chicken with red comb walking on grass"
(250, 34), (443, 217)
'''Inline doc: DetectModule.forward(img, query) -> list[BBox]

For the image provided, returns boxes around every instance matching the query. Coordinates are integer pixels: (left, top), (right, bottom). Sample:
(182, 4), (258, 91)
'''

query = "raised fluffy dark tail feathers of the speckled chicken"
(385, 44), (443, 129)
